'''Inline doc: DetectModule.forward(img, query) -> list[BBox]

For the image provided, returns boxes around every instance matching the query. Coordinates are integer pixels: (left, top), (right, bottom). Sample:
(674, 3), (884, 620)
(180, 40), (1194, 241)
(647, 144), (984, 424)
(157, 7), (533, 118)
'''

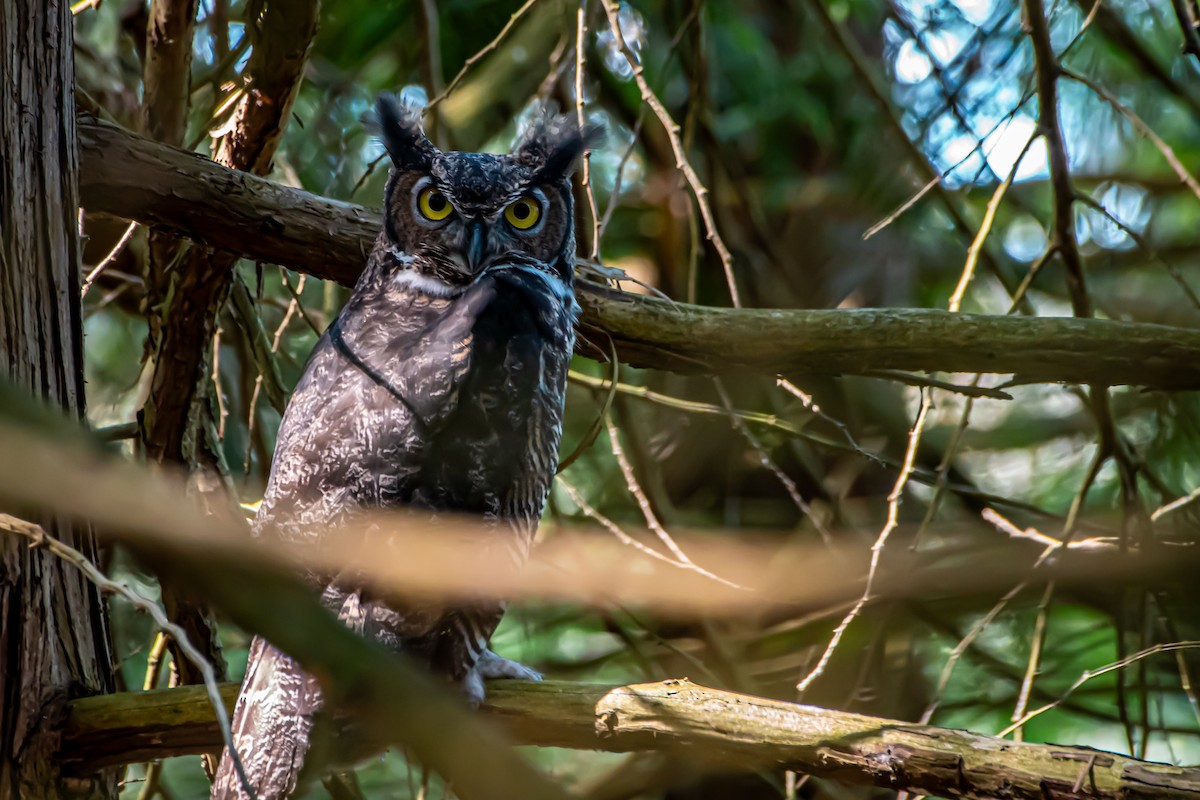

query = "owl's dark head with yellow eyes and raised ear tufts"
(377, 95), (596, 294)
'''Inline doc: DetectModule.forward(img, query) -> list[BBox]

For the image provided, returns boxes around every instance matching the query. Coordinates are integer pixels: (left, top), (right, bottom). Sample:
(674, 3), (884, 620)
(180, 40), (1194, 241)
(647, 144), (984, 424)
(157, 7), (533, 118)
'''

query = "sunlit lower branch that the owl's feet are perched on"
(62, 680), (1200, 800)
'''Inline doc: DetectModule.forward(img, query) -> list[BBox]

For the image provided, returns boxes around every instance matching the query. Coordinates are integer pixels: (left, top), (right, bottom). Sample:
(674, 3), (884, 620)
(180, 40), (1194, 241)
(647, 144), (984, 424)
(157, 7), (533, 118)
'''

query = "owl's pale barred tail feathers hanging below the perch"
(211, 637), (322, 800)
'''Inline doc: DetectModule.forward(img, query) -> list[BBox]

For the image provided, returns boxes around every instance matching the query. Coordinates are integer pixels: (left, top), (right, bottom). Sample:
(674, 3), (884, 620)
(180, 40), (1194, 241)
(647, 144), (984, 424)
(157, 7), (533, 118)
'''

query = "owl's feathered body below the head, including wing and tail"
(212, 226), (578, 800)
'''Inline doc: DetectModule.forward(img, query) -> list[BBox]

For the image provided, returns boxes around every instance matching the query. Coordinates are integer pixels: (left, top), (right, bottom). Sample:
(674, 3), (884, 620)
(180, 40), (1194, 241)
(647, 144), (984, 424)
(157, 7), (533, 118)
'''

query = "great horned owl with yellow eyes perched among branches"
(212, 96), (593, 800)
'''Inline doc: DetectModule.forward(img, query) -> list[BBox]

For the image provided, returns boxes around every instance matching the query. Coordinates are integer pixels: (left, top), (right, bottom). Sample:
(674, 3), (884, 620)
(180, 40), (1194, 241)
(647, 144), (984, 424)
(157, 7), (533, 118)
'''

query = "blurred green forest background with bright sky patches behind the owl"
(74, 0), (1200, 800)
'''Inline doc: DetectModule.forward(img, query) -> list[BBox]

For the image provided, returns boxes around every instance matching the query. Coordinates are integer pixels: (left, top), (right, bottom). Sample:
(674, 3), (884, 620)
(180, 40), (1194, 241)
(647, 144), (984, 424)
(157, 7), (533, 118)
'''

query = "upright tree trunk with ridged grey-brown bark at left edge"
(0, 0), (116, 800)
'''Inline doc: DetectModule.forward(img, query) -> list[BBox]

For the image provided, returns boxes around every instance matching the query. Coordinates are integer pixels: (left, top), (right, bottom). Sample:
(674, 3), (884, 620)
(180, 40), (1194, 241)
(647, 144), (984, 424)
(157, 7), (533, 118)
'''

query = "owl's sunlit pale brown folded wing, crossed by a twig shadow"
(254, 279), (496, 540)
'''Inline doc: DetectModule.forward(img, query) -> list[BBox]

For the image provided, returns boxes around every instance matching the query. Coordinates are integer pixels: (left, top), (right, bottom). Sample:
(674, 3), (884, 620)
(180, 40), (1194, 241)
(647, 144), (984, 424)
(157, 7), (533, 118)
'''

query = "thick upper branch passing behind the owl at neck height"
(79, 118), (1200, 389)
